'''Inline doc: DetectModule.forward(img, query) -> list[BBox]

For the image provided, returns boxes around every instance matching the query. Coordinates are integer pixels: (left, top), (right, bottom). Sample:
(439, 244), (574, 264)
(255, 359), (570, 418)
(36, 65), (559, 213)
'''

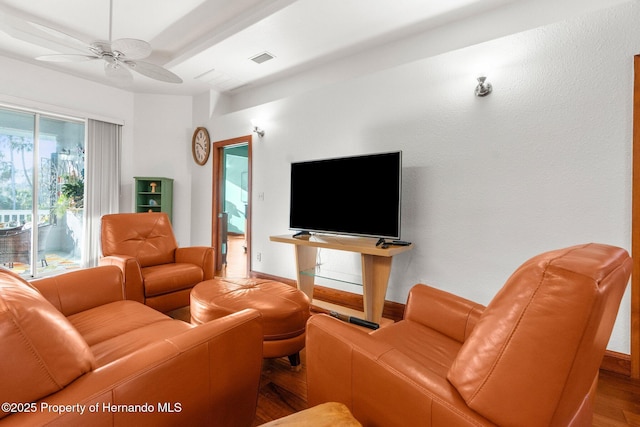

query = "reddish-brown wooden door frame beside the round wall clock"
(211, 135), (252, 276)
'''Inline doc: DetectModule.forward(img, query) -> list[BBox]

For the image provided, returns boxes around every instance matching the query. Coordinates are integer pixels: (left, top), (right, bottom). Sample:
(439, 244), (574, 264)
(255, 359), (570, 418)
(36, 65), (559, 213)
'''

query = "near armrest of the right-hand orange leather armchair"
(306, 315), (483, 425)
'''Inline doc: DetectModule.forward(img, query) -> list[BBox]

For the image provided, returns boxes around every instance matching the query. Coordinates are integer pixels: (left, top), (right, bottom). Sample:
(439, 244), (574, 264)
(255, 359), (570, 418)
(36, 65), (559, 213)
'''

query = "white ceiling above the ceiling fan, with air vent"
(0, 0), (632, 95)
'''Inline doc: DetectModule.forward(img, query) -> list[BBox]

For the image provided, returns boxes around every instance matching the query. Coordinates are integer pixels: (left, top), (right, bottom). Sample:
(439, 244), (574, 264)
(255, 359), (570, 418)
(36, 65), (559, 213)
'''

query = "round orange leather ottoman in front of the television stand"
(190, 277), (310, 367)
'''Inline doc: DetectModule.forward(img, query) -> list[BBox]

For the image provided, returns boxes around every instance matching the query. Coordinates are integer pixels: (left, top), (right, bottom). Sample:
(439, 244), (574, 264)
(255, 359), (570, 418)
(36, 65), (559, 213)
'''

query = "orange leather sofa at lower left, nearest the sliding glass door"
(0, 266), (263, 427)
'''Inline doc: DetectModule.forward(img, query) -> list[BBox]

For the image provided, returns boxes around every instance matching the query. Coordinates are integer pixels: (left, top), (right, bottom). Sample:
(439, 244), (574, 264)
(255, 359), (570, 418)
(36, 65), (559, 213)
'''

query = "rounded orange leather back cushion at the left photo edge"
(0, 270), (96, 418)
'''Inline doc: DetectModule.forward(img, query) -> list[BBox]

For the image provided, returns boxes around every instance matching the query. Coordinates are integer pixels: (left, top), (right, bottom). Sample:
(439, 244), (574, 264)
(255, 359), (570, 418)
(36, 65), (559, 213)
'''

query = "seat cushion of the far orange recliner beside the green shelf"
(142, 263), (204, 297)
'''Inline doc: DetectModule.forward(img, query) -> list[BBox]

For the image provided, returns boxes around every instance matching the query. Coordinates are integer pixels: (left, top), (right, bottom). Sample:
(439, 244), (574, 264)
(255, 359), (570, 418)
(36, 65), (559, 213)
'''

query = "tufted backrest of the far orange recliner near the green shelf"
(101, 212), (178, 267)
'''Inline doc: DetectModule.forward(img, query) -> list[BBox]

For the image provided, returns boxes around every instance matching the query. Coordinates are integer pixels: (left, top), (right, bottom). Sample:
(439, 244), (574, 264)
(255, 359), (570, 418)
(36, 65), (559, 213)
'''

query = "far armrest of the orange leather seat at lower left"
(31, 266), (124, 316)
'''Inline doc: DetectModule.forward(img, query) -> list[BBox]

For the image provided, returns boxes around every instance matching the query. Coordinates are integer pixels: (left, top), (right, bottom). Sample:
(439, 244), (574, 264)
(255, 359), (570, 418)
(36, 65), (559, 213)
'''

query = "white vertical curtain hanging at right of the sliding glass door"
(82, 120), (122, 267)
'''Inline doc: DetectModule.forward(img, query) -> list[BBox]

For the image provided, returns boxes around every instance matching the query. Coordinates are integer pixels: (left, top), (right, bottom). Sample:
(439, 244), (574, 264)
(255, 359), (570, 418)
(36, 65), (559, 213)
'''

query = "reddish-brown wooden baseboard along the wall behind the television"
(250, 271), (631, 377)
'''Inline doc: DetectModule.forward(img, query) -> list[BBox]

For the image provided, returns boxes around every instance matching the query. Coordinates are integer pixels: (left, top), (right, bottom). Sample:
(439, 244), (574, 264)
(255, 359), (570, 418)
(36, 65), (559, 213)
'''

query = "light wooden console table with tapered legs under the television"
(270, 235), (413, 323)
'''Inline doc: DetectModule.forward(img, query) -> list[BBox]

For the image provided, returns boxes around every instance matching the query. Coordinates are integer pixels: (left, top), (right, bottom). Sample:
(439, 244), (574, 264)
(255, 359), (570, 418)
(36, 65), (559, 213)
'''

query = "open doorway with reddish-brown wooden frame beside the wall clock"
(211, 135), (251, 277)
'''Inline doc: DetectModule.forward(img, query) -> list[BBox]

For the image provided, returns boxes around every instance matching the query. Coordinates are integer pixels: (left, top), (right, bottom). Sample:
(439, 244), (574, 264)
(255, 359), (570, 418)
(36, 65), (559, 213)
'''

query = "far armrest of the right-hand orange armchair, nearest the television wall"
(404, 284), (485, 342)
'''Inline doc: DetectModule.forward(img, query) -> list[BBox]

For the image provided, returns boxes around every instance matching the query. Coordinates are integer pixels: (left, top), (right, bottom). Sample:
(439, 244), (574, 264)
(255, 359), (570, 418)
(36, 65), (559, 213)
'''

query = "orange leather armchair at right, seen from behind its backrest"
(306, 244), (632, 427)
